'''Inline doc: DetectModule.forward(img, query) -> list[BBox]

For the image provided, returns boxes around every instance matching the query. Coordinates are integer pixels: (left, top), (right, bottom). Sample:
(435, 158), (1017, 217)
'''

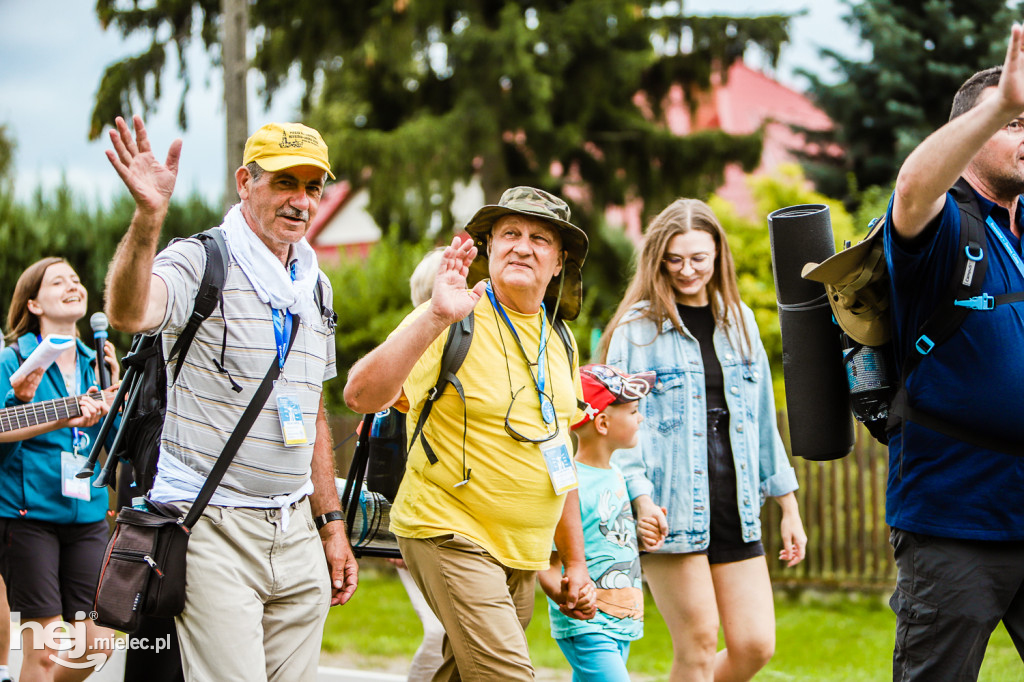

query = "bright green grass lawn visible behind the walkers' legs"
(324, 561), (1024, 682)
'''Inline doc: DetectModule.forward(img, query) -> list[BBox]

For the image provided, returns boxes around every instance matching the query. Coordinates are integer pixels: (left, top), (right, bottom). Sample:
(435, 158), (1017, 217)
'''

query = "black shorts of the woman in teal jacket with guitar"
(0, 518), (110, 622)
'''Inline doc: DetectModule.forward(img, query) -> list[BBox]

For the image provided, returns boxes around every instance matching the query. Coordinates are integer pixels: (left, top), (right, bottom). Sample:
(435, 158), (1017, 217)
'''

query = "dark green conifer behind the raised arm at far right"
(804, 0), (1024, 198)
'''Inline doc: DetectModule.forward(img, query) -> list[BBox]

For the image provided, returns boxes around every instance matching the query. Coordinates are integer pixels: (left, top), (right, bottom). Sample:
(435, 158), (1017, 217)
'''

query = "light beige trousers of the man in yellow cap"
(175, 493), (331, 682)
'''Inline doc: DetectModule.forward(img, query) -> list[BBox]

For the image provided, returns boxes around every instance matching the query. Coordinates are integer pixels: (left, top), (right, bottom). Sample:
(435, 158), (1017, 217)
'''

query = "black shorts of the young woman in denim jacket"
(700, 409), (765, 564)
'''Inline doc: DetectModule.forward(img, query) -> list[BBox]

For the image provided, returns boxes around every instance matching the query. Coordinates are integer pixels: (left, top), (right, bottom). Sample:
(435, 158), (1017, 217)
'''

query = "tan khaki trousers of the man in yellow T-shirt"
(398, 535), (536, 682)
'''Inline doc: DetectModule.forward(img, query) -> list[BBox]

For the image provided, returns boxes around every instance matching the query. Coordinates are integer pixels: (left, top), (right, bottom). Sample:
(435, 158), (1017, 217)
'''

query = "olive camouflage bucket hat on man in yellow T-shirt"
(466, 187), (590, 319)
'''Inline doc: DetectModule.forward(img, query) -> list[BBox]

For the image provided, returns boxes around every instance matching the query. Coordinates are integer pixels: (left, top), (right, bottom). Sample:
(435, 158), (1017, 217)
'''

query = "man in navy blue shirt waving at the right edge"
(885, 24), (1024, 681)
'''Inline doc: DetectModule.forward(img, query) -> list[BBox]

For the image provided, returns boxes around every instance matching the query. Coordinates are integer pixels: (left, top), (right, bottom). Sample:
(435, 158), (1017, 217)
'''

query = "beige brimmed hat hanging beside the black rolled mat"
(801, 218), (891, 346)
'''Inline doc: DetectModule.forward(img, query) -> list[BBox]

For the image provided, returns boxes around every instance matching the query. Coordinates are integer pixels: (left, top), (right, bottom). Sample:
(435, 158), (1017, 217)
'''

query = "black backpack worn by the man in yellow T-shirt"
(339, 312), (574, 559)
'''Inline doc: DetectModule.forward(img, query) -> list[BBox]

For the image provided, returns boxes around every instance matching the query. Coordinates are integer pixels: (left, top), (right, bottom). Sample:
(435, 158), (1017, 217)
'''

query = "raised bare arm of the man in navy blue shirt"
(893, 24), (1024, 239)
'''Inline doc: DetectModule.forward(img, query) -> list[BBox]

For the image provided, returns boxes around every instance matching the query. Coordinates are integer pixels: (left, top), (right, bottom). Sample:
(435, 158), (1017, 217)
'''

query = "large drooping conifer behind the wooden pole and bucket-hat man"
(91, 0), (788, 232)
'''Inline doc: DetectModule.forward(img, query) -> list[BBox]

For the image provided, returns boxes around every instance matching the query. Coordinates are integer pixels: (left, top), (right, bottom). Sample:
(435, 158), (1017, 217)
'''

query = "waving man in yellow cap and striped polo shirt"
(106, 117), (356, 681)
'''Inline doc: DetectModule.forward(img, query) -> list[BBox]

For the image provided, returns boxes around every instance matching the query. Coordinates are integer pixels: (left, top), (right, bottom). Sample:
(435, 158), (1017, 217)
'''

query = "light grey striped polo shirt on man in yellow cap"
(147, 240), (337, 498)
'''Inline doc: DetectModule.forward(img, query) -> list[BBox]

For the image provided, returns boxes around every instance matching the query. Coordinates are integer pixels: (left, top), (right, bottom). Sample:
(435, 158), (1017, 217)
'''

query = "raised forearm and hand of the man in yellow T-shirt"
(345, 239), (485, 414)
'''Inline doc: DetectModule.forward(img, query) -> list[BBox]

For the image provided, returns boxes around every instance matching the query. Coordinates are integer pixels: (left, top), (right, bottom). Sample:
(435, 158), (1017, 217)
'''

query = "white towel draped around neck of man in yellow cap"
(222, 204), (319, 324)
